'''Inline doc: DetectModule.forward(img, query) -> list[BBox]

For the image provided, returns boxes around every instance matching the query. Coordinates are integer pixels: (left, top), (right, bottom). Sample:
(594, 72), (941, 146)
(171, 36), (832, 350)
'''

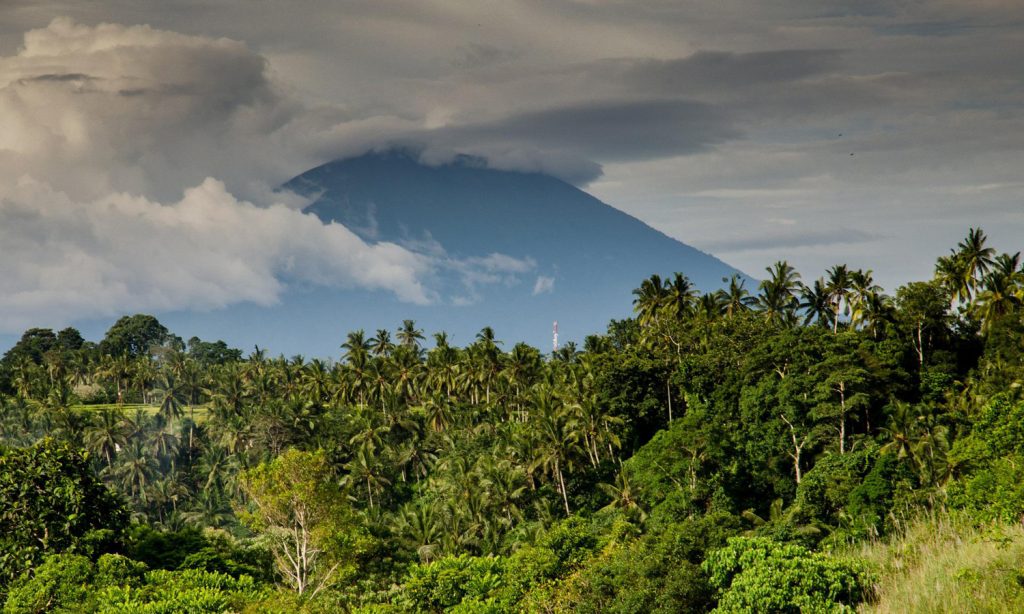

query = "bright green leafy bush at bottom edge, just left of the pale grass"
(702, 537), (871, 613)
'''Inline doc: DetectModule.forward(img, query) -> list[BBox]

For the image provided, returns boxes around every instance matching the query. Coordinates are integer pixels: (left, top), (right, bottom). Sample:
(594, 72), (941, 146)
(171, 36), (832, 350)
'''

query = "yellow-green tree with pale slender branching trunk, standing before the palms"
(239, 449), (368, 597)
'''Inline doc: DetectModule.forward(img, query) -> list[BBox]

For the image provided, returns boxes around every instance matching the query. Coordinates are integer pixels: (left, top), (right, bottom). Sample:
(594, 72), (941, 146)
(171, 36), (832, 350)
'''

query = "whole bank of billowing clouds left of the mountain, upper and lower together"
(0, 18), (529, 332)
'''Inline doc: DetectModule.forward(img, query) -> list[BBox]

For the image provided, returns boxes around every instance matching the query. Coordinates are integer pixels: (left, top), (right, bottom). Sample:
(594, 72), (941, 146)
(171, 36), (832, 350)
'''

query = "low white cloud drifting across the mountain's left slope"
(0, 179), (435, 332)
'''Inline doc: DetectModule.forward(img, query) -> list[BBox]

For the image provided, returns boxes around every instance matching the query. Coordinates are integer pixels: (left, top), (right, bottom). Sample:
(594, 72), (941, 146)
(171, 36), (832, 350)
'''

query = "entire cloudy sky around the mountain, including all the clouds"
(0, 0), (1024, 333)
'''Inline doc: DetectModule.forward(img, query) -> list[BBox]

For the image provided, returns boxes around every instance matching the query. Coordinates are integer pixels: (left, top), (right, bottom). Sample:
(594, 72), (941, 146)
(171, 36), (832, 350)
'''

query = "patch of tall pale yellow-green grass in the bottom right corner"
(847, 513), (1024, 614)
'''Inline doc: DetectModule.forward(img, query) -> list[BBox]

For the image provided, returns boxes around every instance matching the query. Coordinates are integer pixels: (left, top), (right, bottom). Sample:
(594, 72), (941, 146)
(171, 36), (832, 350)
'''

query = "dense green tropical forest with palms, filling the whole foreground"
(0, 228), (1024, 613)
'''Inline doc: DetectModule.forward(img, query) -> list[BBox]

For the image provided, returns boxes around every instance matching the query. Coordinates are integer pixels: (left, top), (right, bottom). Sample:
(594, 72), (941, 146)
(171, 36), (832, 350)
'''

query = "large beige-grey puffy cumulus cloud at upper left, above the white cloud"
(0, 18), (315, 205)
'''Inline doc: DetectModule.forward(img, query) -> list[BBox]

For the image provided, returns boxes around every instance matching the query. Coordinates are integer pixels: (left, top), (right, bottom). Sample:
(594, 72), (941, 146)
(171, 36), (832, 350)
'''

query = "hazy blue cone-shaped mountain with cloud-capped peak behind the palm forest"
(0, 152), (753, 357)
